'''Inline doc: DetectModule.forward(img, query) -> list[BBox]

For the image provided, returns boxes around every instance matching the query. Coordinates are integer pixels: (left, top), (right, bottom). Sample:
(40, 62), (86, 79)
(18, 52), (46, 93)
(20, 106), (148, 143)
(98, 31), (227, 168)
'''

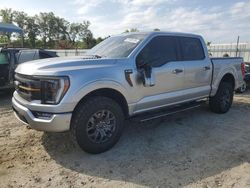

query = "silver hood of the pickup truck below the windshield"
(15, 56), (117, 75)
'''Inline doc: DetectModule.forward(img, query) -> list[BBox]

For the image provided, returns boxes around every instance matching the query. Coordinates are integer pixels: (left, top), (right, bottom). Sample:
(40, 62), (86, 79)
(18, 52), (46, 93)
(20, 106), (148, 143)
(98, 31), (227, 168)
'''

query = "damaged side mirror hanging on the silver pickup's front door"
(141, 64), (155, 87)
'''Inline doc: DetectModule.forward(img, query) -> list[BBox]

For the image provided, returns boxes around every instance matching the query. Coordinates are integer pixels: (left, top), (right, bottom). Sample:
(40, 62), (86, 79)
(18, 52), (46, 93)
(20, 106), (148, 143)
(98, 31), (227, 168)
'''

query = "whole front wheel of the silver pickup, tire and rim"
(71, 97), (124, 154)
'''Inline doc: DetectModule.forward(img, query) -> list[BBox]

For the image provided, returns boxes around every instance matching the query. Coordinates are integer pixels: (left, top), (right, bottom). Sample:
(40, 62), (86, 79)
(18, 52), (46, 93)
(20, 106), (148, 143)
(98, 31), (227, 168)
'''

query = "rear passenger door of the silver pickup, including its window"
(179, 37), (212, 98)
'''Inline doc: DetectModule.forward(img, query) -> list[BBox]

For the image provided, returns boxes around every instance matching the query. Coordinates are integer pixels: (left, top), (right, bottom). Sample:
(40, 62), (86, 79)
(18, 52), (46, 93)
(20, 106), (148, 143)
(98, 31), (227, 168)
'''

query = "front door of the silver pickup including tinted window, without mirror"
(135, 35), (184, 112)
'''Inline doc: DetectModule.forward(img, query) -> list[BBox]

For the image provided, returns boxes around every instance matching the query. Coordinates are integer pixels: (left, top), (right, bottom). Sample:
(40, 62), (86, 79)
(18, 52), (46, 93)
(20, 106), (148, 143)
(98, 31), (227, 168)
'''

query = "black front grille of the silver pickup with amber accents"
(15, 74), (41, 101)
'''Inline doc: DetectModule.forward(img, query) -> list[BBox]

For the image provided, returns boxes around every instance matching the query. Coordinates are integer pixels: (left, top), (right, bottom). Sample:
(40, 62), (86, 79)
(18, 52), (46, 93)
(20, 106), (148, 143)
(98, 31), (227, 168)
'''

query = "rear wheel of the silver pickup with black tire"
(209, 82), (234, 114)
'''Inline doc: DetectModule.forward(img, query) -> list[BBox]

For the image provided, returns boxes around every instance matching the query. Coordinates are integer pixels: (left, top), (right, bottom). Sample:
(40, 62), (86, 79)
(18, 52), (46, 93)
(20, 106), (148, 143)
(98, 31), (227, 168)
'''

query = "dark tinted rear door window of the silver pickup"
(179, 37), (205, 61)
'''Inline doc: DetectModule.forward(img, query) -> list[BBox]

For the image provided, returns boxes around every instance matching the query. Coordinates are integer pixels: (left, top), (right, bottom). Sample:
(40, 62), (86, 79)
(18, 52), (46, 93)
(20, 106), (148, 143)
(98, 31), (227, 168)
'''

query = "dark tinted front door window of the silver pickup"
(136, 36), (177, 67)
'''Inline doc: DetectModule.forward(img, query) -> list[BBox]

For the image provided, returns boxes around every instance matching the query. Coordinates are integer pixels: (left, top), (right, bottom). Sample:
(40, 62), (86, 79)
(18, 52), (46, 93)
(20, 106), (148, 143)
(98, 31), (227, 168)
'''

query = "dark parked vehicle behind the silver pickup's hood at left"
(0, 48), (57, 90)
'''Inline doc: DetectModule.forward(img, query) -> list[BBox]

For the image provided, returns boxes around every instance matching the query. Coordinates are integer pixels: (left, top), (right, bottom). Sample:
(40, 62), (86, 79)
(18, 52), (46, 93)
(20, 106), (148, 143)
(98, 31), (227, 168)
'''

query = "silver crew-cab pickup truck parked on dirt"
(12, 32), (245, 153)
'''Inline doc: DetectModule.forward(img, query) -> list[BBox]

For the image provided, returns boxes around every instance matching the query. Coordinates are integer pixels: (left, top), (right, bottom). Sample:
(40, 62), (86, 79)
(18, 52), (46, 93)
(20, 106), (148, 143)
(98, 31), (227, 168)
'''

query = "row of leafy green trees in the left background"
(0, 9), (100, 48)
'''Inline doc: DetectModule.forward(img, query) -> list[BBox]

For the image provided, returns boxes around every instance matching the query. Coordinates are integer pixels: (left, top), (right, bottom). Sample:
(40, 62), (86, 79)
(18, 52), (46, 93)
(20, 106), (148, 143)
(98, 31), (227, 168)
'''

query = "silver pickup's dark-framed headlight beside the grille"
(40, 77), (70, 104)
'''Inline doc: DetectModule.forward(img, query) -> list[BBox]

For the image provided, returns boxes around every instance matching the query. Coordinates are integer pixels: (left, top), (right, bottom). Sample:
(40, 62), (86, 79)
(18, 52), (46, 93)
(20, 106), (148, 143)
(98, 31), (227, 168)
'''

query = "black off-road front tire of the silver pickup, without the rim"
(71, 96), (124, 154)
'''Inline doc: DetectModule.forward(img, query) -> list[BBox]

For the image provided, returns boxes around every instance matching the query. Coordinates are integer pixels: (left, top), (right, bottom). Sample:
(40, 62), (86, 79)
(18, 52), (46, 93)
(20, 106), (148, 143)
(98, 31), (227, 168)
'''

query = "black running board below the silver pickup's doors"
(131, 100), (206, 123)
